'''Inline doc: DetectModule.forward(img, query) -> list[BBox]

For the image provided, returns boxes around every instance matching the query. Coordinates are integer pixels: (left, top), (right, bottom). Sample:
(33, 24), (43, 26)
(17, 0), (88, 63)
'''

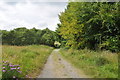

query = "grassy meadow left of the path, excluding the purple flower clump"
(2, 45), (53, 77)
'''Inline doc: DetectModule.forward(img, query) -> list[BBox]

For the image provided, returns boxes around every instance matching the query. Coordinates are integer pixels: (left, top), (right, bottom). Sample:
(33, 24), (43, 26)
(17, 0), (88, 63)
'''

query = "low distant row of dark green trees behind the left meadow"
(0, 27), (58, 46)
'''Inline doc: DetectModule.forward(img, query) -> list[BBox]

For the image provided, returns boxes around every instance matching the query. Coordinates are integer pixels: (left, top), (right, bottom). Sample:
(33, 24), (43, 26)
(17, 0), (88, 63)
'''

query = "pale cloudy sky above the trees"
(0, 0), (67, 31)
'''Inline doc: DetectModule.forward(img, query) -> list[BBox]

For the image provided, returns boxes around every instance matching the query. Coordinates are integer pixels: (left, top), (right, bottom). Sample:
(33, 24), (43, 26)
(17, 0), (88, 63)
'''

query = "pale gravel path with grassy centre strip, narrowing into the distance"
(38, 49), (87, 78)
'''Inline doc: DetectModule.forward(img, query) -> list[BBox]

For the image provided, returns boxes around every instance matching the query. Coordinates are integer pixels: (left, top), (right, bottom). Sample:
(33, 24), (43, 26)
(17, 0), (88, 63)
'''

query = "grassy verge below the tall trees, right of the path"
(60, 49), (118, 78)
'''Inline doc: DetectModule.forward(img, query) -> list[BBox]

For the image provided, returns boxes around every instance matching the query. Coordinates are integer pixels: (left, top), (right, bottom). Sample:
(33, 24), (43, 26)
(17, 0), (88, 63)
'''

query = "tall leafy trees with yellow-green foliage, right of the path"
(57, 2), (120, 52)
